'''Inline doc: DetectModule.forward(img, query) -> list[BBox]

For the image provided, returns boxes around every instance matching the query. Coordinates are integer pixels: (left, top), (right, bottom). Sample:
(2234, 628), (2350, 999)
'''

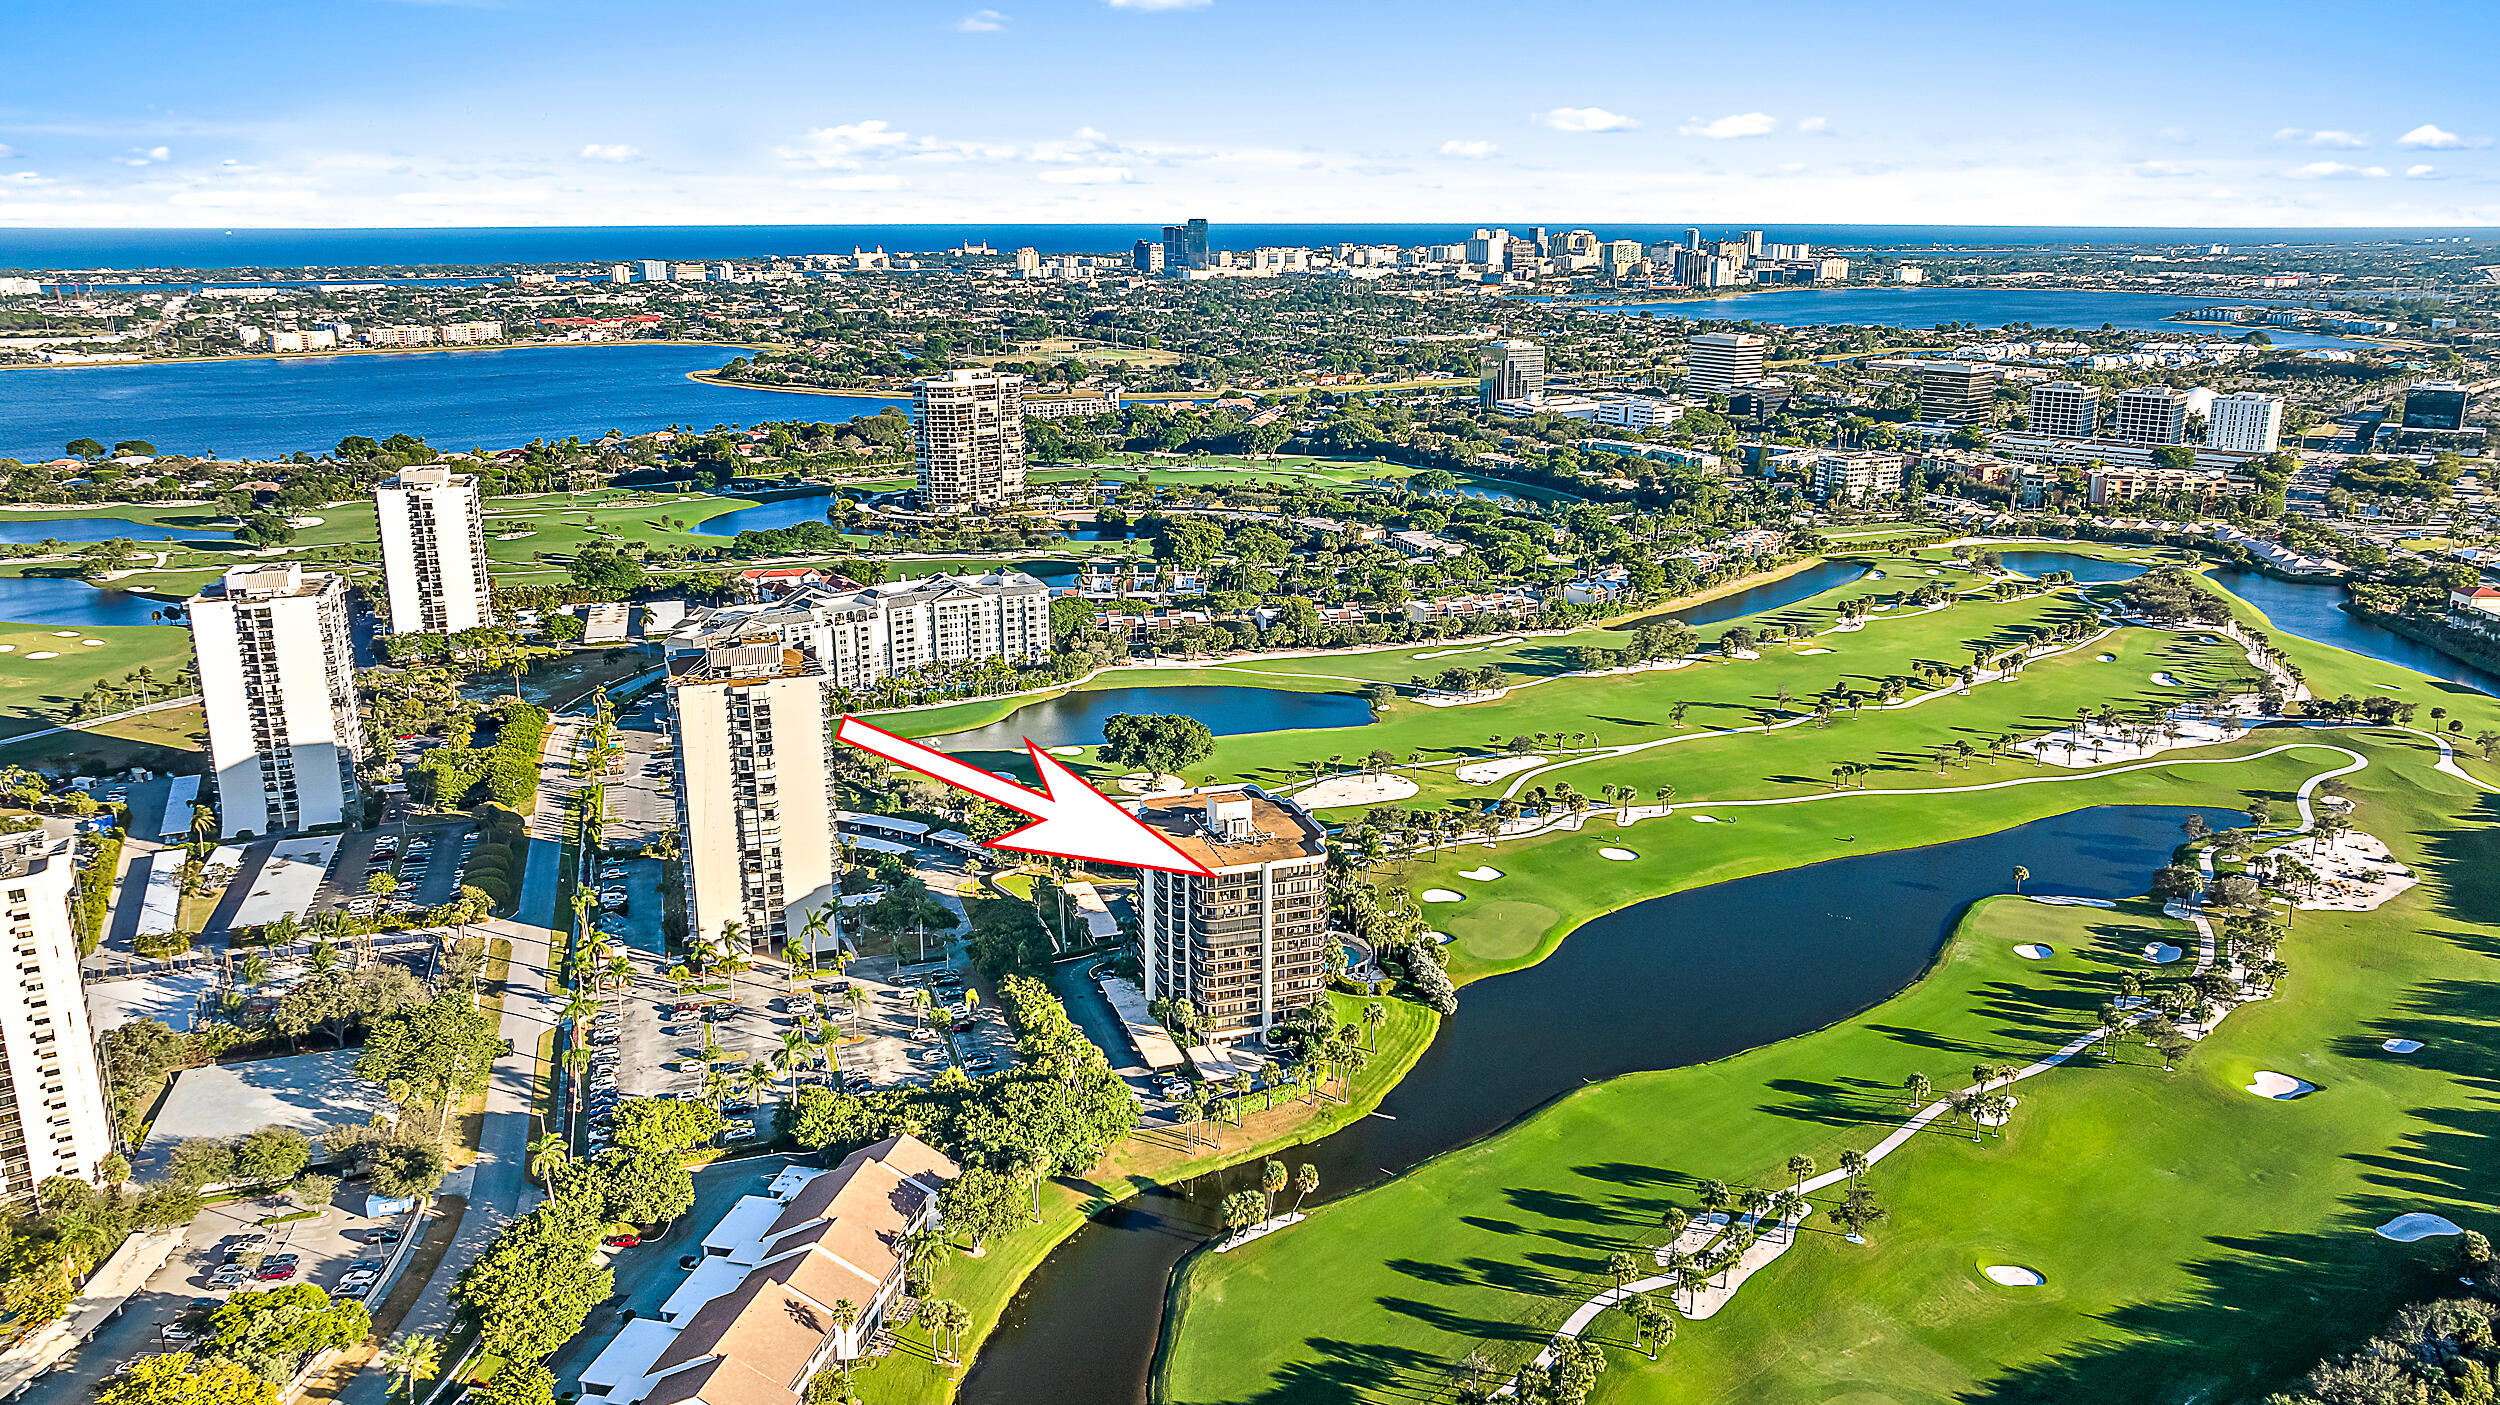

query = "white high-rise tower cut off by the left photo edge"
(0, 830), (113, 1200)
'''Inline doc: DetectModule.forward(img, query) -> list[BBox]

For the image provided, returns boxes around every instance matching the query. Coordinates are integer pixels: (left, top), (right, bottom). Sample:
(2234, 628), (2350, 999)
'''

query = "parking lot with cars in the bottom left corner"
(18, 1185), (410, 1405)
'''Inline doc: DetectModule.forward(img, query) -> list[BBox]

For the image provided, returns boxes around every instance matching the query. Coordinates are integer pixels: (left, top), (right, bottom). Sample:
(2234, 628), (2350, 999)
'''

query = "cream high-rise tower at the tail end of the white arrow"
(668, 643), (840, 950)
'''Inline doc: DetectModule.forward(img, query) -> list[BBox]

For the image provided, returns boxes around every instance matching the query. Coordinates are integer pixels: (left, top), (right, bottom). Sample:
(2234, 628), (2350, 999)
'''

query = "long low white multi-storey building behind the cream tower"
(668, 570), (1050, 688)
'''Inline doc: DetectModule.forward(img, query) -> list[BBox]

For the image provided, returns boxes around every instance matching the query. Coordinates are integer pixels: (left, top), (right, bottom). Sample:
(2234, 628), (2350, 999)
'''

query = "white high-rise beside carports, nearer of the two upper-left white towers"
(188, 563), (365, 838)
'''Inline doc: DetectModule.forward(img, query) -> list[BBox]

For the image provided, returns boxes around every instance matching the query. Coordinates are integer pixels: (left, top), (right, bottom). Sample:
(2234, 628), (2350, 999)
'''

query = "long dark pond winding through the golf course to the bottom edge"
(963, 805), (2248, 1405)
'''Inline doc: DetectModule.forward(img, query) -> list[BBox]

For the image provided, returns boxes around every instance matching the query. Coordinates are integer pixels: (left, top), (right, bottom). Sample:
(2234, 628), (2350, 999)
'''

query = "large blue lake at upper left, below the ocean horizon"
(0, 345), (903, 460)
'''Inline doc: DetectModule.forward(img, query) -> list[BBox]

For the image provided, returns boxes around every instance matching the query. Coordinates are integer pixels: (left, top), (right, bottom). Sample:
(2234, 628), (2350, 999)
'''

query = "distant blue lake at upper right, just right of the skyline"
(1603, 288), (2360, 348)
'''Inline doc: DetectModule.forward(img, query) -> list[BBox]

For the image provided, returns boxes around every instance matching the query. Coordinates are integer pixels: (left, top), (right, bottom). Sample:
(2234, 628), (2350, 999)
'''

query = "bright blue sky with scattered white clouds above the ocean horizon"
(0, 0), (2500, 228)
